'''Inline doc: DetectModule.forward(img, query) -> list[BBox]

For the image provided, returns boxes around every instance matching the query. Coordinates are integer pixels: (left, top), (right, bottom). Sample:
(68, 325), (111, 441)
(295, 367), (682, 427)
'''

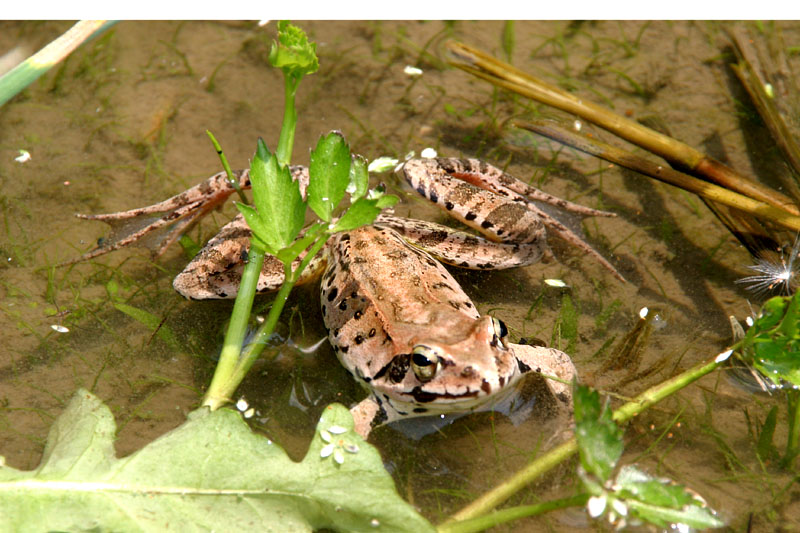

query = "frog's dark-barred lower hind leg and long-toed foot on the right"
(403, 158), (624, 281)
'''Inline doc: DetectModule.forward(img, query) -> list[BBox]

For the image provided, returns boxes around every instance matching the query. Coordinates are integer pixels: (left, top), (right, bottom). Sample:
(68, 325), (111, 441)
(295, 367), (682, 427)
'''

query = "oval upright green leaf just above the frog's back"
(306, 131), (351, 222)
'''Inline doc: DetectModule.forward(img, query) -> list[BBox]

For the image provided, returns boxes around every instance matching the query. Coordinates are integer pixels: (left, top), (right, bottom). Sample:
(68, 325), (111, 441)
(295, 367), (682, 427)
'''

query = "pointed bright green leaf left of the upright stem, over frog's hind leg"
(245, 139), (306, 253)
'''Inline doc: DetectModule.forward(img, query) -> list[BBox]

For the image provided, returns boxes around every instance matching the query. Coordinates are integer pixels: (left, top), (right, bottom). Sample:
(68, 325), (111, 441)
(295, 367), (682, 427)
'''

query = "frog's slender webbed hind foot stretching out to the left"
(71, 170), (250, 263)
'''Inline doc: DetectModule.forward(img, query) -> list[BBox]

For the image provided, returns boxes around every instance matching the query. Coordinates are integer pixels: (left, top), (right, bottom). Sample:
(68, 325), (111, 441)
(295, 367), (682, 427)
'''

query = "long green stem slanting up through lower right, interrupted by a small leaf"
(445, 357), (721, 525)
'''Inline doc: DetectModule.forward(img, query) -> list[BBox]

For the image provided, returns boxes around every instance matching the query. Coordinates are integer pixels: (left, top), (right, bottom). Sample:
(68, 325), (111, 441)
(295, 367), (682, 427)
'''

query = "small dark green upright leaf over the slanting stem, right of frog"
(574, 385), (623, 482)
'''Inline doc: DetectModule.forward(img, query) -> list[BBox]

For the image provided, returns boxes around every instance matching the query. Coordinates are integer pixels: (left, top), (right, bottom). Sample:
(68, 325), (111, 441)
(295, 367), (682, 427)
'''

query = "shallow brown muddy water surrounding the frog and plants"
(0, 22), (800, 531)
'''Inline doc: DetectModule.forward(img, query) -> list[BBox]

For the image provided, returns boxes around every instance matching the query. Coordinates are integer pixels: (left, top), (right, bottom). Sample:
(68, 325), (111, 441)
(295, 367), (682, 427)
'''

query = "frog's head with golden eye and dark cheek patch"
(370, 316), (521, 416)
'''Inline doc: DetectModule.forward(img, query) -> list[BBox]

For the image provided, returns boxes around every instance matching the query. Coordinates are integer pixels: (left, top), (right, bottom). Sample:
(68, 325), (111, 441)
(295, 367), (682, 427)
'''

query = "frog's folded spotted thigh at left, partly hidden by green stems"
(172, 215), (327, 300)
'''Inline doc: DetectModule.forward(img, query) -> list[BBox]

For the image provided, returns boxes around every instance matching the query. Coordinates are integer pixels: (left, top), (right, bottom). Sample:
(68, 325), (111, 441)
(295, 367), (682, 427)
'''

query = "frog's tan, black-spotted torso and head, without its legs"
(322, 226), (574, 432)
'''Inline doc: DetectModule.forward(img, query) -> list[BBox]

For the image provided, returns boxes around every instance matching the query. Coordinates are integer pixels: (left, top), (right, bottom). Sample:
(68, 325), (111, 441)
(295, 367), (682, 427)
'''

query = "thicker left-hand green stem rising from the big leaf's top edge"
(202, 240), (266, 411)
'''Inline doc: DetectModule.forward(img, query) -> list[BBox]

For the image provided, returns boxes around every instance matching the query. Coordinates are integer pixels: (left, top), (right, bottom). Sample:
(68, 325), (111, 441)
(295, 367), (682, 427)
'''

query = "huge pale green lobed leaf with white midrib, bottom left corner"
(0, 390), (433, 532)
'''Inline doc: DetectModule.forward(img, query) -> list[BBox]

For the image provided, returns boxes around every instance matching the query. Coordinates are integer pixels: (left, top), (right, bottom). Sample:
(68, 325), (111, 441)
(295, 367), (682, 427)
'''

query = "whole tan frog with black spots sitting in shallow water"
(79, 158), (624, 438)
